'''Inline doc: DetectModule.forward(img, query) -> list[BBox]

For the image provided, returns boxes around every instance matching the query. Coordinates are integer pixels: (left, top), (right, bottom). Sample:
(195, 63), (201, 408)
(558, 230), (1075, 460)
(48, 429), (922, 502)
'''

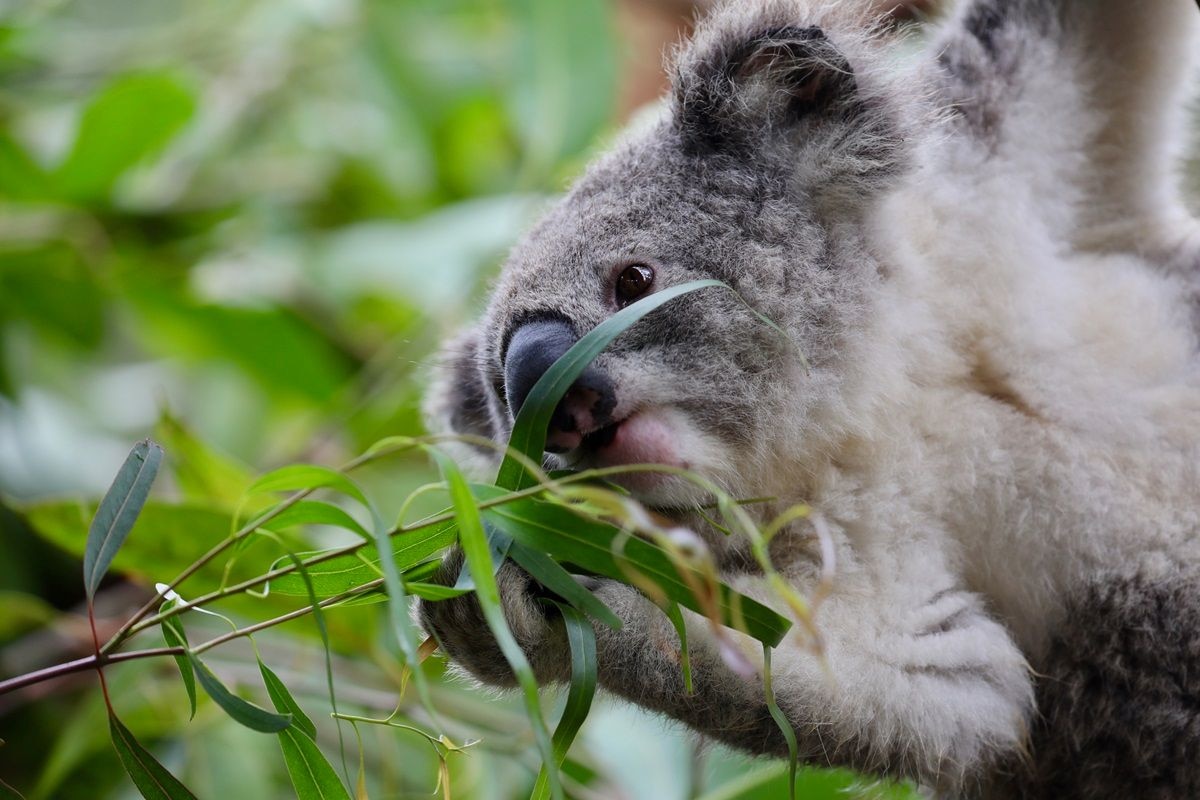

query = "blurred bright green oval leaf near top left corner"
(54, 73), (196, 200)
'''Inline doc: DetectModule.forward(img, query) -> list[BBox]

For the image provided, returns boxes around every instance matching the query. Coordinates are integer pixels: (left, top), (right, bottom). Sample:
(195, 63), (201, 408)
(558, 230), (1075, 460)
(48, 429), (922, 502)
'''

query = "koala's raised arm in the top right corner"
(931, 0), (1200, 271)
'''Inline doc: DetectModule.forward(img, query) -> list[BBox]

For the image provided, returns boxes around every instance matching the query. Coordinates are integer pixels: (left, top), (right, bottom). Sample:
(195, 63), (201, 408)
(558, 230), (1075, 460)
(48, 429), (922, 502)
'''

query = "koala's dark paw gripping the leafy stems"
(416, 551), (570, 687)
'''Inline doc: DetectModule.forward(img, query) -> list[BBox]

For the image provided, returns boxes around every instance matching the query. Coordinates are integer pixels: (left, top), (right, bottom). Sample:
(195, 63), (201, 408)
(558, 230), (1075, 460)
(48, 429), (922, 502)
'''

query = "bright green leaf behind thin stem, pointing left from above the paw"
(270, 522), (458, 599)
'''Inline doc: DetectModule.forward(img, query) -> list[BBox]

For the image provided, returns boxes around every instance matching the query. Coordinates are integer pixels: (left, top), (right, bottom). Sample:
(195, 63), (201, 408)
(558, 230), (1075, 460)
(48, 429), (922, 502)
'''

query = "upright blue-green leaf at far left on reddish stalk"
(83, 439), (162, 601)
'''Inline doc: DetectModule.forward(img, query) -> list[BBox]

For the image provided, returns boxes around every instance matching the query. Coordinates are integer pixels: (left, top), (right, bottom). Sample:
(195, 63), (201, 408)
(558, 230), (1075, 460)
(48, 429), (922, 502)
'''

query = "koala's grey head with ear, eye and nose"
(428, 2), (906, 506)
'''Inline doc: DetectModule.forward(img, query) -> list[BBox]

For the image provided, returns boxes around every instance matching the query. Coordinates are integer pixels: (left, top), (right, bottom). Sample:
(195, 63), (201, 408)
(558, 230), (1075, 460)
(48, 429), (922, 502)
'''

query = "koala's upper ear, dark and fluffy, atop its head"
(673, 19), (859, 154)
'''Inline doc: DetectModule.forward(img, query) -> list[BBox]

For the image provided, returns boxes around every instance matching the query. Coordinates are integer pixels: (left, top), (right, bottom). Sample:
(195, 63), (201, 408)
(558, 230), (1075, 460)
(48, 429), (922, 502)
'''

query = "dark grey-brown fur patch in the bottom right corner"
(988, 572), (1200, 800)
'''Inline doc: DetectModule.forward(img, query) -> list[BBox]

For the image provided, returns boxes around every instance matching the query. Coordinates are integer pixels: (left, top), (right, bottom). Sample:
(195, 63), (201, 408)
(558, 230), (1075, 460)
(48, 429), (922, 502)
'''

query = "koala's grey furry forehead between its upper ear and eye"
(487, 119), (827, 357)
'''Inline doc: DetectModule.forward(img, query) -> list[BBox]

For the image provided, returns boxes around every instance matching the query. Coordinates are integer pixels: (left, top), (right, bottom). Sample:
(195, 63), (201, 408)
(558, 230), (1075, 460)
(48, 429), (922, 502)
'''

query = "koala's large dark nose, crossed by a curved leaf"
(504, 319), (617, 452)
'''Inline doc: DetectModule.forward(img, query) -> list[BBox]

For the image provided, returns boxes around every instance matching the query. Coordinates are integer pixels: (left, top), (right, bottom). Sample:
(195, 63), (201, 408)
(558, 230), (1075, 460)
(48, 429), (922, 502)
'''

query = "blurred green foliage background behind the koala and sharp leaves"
(0, 0), (921, 799)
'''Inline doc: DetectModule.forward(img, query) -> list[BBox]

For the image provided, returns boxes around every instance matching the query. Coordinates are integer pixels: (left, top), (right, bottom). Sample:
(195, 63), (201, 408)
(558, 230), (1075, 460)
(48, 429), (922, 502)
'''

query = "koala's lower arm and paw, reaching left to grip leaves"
(419, 527), (1032, 790)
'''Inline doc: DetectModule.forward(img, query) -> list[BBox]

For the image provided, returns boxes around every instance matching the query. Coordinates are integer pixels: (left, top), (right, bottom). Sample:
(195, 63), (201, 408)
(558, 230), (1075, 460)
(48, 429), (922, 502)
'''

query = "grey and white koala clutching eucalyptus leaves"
(418, 0), (1200, 799)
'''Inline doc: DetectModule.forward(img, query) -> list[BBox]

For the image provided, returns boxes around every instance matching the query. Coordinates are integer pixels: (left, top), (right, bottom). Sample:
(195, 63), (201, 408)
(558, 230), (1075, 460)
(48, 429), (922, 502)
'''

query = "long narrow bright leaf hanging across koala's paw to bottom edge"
(430, 450), (563, 800)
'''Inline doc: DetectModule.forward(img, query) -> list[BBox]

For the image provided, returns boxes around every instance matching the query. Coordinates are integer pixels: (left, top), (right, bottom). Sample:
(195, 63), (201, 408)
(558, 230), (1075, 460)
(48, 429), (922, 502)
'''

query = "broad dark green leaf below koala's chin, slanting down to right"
(472, 483), (792, 646)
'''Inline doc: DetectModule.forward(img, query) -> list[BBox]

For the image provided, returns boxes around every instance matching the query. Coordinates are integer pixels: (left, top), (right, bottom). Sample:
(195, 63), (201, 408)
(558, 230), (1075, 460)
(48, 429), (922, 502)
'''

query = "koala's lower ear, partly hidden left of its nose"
(424, 329), (500, 469)
